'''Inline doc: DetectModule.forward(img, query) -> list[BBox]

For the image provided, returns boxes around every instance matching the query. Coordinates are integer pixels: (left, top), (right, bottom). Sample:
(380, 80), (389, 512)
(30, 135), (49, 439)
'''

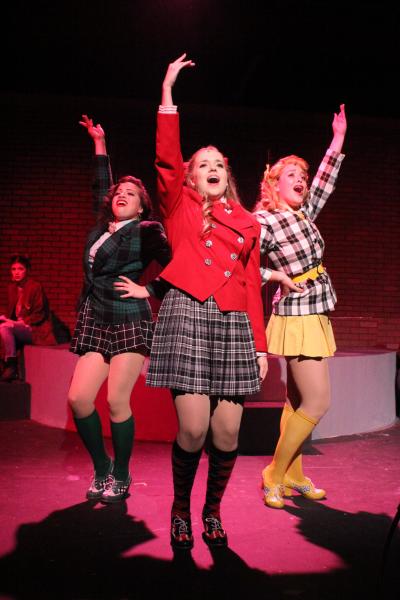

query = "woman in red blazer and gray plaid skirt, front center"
(119, 54), (267, 549)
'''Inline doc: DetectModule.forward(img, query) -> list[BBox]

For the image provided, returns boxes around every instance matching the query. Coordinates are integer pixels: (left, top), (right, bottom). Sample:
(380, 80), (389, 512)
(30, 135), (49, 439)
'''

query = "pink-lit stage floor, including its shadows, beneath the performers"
(0, 420), (400, 600)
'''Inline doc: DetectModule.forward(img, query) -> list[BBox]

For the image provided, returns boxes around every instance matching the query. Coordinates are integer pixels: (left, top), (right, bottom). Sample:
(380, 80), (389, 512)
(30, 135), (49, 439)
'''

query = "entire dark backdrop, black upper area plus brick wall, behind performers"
(0, 0), (400, 349)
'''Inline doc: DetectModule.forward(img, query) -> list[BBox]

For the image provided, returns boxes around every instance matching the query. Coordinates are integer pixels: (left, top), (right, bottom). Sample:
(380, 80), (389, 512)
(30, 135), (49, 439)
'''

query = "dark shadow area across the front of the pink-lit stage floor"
(0, 498), (400, 600)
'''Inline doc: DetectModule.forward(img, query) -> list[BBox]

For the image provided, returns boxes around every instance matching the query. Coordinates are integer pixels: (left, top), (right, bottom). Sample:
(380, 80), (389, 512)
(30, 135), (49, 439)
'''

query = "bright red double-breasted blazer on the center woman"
(156, 113), (266, 352)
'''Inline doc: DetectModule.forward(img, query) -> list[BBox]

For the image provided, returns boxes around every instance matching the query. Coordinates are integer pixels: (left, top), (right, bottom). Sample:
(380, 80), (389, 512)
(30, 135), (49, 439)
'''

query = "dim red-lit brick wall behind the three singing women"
(0, 95), (400, 348)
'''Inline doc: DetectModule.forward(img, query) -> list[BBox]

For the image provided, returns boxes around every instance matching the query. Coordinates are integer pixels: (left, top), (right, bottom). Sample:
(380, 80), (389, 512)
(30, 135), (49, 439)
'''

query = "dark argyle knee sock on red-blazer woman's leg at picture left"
(172, 441), (202, 519)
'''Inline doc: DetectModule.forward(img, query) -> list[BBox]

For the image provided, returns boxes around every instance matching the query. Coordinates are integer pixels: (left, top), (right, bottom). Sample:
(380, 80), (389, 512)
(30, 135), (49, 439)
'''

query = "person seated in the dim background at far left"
(0, 254), (56, 381)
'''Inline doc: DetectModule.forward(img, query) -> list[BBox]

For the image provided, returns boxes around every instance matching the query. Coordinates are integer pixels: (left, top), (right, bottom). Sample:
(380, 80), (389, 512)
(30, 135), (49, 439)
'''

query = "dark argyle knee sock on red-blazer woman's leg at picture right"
(203, 444), (238, 518)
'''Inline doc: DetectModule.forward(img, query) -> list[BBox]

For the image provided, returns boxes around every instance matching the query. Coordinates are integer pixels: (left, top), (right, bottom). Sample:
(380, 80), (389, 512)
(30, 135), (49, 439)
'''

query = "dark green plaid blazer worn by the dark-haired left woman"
(79, 155), (171, 325)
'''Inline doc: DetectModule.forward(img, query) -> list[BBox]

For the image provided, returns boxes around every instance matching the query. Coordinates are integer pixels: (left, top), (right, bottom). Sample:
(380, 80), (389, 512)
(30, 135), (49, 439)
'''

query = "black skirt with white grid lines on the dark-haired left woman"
(70, 298), (154, 359)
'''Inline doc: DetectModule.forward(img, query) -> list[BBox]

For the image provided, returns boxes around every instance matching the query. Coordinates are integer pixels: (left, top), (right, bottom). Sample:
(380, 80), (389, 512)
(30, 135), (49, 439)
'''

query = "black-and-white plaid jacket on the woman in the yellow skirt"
(254, 150), (344, 316)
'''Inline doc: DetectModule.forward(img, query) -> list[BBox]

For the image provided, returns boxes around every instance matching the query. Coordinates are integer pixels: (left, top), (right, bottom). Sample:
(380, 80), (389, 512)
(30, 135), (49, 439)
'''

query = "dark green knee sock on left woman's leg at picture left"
(74, 410), (110, 477)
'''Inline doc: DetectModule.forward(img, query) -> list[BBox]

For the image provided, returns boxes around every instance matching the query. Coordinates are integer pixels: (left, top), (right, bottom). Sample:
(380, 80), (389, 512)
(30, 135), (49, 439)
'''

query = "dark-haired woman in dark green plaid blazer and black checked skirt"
(69, 115), (170, 503)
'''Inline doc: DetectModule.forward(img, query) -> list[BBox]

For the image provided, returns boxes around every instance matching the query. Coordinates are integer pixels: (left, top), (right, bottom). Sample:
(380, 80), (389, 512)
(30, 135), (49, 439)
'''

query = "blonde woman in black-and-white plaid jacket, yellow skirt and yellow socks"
(255, 105), (347, 508)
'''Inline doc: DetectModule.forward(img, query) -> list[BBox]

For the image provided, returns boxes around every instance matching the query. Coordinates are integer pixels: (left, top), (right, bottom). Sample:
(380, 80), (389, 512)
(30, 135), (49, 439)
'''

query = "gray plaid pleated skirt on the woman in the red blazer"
(146, 289), (260, 397)
